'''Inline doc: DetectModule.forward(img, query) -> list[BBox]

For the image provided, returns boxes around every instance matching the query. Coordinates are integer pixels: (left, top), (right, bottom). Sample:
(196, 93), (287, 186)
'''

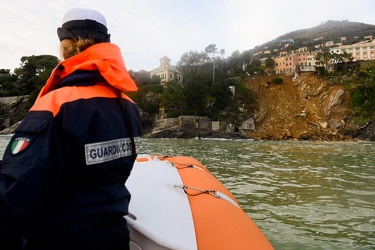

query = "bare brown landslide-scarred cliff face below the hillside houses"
(247, 73), (354, 140)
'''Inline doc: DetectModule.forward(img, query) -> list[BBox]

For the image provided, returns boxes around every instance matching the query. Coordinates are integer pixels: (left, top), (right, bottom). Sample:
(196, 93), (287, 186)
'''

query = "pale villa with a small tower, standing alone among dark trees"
(150, 56), (183, 84)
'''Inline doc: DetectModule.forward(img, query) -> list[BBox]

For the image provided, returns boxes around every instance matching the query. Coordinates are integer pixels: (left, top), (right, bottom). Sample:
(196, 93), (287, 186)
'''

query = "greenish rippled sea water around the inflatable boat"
(0, 135), (375, 250)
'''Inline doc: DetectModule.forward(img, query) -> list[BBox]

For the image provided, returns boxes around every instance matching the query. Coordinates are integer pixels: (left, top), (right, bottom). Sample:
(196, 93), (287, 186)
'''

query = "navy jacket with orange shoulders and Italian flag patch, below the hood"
(0, 42), (141, 237)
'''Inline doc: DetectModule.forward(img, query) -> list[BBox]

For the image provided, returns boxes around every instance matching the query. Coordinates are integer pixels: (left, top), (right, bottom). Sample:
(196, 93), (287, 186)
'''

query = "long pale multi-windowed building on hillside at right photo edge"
(329, 40), (375, 61)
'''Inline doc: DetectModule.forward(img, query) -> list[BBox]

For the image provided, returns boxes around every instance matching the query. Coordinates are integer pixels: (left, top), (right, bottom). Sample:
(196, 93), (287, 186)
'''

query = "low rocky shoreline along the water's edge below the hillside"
(0, 97), (375, 141)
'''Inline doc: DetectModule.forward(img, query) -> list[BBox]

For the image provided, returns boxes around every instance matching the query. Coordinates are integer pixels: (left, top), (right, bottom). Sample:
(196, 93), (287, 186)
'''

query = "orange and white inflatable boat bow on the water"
(126, 155), (273, 250)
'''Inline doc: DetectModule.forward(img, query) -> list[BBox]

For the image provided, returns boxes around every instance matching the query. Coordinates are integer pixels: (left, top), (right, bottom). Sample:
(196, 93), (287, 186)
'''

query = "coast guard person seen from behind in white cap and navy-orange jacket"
(0, 9), (141, 250)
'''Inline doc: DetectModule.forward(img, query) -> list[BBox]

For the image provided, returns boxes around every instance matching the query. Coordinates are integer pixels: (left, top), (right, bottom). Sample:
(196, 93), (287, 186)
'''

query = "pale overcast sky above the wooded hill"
(0, 0), (375, 71)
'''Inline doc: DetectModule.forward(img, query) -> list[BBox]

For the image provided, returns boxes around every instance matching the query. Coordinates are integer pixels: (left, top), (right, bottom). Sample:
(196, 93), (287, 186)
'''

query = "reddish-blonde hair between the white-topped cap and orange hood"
(60, 38), (98, 60)
